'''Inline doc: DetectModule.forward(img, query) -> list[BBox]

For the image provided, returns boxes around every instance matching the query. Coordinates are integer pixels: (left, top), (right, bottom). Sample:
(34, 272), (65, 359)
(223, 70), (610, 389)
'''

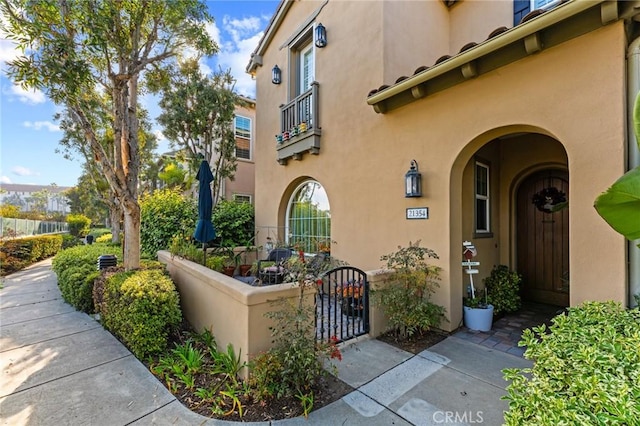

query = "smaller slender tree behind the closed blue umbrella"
(154, 59), (242, 206)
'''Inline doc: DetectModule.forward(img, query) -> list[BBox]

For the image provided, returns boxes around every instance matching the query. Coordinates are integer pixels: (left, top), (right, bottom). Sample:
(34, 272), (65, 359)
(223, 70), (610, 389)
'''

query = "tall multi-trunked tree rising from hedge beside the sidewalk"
(0, 0), (217, 269)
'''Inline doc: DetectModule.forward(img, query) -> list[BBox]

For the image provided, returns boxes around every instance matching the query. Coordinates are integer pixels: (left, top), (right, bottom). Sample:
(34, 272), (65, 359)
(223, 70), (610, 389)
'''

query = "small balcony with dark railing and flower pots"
(276, 81), (322, 166)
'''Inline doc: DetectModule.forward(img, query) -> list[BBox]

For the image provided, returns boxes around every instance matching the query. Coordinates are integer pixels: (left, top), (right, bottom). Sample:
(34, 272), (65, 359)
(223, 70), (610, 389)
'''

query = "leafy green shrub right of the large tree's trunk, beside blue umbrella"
(140, 189), (198, 259)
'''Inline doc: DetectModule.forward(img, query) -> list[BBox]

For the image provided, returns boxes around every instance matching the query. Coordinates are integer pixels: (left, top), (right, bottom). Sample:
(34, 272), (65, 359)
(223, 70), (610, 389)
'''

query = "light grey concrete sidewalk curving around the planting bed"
(0, 260), (530, 425)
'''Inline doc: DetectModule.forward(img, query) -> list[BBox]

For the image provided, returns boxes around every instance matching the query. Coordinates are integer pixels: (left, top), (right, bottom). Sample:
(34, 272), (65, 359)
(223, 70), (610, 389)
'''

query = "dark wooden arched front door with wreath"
(516, 170), (569, 306)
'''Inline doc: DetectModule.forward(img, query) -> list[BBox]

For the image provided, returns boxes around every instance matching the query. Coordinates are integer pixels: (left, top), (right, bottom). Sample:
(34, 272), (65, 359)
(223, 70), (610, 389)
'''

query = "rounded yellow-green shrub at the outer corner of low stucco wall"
(100, 269), (182, 359)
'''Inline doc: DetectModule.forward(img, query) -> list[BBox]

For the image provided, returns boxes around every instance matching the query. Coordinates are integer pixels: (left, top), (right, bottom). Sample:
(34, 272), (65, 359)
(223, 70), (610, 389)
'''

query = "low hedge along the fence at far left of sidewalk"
(0, 234), (63, 275)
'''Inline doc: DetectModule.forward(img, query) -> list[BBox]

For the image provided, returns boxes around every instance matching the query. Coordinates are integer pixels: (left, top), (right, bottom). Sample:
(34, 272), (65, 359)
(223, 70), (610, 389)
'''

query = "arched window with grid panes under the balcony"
(287, 180), (331, 253)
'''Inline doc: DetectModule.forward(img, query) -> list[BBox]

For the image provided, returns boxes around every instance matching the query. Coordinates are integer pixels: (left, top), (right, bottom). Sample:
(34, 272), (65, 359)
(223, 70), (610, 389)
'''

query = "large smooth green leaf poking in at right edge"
(594, 167), (640, 240)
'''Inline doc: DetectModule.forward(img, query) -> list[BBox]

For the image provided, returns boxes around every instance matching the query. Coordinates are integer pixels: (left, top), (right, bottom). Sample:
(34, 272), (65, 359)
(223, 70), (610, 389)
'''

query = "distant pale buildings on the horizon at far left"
(0, 183), (71, 214)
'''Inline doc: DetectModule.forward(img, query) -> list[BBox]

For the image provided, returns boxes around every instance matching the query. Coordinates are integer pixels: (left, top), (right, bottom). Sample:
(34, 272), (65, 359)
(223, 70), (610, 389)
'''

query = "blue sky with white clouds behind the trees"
(0, 0), (279, 186)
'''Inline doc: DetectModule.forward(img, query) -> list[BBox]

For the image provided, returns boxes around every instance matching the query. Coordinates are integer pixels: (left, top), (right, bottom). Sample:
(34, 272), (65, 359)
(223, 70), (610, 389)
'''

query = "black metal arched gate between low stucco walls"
(316, 266), (369, 342)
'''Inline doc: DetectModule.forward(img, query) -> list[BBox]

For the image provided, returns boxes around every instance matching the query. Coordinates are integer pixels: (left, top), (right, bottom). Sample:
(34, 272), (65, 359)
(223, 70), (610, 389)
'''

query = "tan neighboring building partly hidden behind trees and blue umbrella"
(156, 97), (256, 203)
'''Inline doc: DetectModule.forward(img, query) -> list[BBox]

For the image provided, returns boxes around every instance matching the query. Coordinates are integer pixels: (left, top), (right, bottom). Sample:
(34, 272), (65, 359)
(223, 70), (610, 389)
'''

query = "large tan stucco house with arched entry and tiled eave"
(247, 0), (640, 330)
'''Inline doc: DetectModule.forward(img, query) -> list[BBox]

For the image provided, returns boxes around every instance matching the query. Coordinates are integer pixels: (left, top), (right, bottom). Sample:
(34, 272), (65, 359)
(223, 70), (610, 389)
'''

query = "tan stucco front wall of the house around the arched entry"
(256, 2), (626, 328)
